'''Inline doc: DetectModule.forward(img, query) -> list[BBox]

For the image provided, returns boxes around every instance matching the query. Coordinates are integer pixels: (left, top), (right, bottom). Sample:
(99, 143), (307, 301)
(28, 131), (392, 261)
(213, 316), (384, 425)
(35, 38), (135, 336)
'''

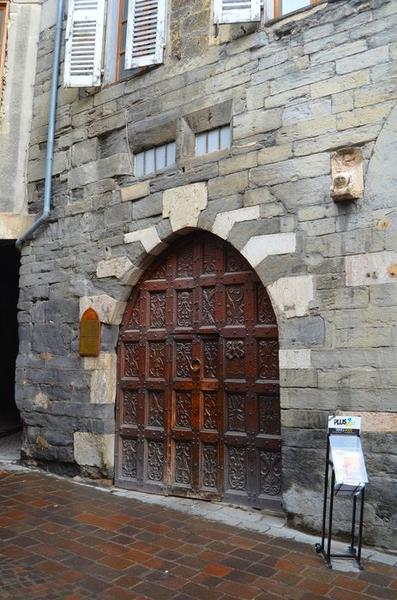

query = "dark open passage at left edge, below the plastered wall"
(0, 241), (20, 436)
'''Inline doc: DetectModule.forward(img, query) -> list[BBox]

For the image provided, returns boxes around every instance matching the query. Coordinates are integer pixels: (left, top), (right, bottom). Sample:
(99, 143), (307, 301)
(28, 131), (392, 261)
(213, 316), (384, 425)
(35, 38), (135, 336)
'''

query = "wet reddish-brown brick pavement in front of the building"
(0, 471), (397, 600)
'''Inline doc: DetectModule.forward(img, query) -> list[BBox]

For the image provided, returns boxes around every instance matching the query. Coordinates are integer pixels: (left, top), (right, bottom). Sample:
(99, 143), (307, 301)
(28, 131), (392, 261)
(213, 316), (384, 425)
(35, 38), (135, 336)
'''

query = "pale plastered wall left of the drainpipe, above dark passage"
(0, 0), (41, 239)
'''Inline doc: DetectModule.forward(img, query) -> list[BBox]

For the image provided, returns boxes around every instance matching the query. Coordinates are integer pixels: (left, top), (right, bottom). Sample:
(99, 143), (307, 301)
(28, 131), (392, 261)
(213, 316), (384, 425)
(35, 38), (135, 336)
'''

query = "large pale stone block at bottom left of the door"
(74, 431), (114, 468)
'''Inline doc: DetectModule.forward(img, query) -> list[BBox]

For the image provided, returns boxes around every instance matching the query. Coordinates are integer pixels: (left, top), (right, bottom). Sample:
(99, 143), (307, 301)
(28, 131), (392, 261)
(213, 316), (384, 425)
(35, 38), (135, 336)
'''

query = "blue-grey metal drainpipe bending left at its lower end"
(15, 0), (64, 250)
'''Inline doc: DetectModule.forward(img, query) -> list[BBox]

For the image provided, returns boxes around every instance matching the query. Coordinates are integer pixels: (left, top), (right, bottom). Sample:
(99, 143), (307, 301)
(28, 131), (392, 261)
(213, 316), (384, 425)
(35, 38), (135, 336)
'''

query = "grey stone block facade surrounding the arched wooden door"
(17, 0), (397, 549)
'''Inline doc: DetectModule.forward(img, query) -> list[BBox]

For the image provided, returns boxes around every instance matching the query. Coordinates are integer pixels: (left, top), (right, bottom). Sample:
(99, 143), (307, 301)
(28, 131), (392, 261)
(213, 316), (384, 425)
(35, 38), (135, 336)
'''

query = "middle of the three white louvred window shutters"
(125, 0), (166, 69)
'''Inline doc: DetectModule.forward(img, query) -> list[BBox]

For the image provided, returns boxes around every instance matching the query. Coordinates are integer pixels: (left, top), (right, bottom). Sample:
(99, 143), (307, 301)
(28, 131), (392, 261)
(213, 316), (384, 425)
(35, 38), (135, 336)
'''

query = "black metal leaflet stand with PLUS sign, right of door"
(315, 416), (368, 569)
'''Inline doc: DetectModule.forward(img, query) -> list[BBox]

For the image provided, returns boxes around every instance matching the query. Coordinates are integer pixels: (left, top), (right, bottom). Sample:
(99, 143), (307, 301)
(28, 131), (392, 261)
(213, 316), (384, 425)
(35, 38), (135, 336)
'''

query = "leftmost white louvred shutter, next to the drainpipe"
(64, 0), (105, 87)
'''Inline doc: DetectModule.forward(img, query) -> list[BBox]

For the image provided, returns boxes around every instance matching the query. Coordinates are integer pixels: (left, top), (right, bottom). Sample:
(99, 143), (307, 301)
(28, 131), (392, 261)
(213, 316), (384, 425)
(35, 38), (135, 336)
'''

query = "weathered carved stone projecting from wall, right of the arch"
(331, 148), (364, 202)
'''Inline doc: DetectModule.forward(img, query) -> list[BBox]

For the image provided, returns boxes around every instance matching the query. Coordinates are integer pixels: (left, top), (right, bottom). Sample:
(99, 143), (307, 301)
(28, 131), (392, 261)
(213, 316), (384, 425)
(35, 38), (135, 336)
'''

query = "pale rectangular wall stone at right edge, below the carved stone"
(345, 252), (397, 286)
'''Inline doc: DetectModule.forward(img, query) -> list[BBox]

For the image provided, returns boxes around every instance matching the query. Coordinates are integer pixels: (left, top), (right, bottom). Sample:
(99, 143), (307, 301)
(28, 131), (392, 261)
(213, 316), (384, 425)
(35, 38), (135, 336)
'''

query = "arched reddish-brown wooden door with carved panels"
(116, 232), (281, 507)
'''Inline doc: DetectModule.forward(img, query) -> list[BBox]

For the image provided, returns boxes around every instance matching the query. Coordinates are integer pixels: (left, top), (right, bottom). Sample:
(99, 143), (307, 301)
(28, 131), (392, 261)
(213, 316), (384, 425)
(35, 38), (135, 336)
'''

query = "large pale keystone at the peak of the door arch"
(163, 183), (208, 231)
